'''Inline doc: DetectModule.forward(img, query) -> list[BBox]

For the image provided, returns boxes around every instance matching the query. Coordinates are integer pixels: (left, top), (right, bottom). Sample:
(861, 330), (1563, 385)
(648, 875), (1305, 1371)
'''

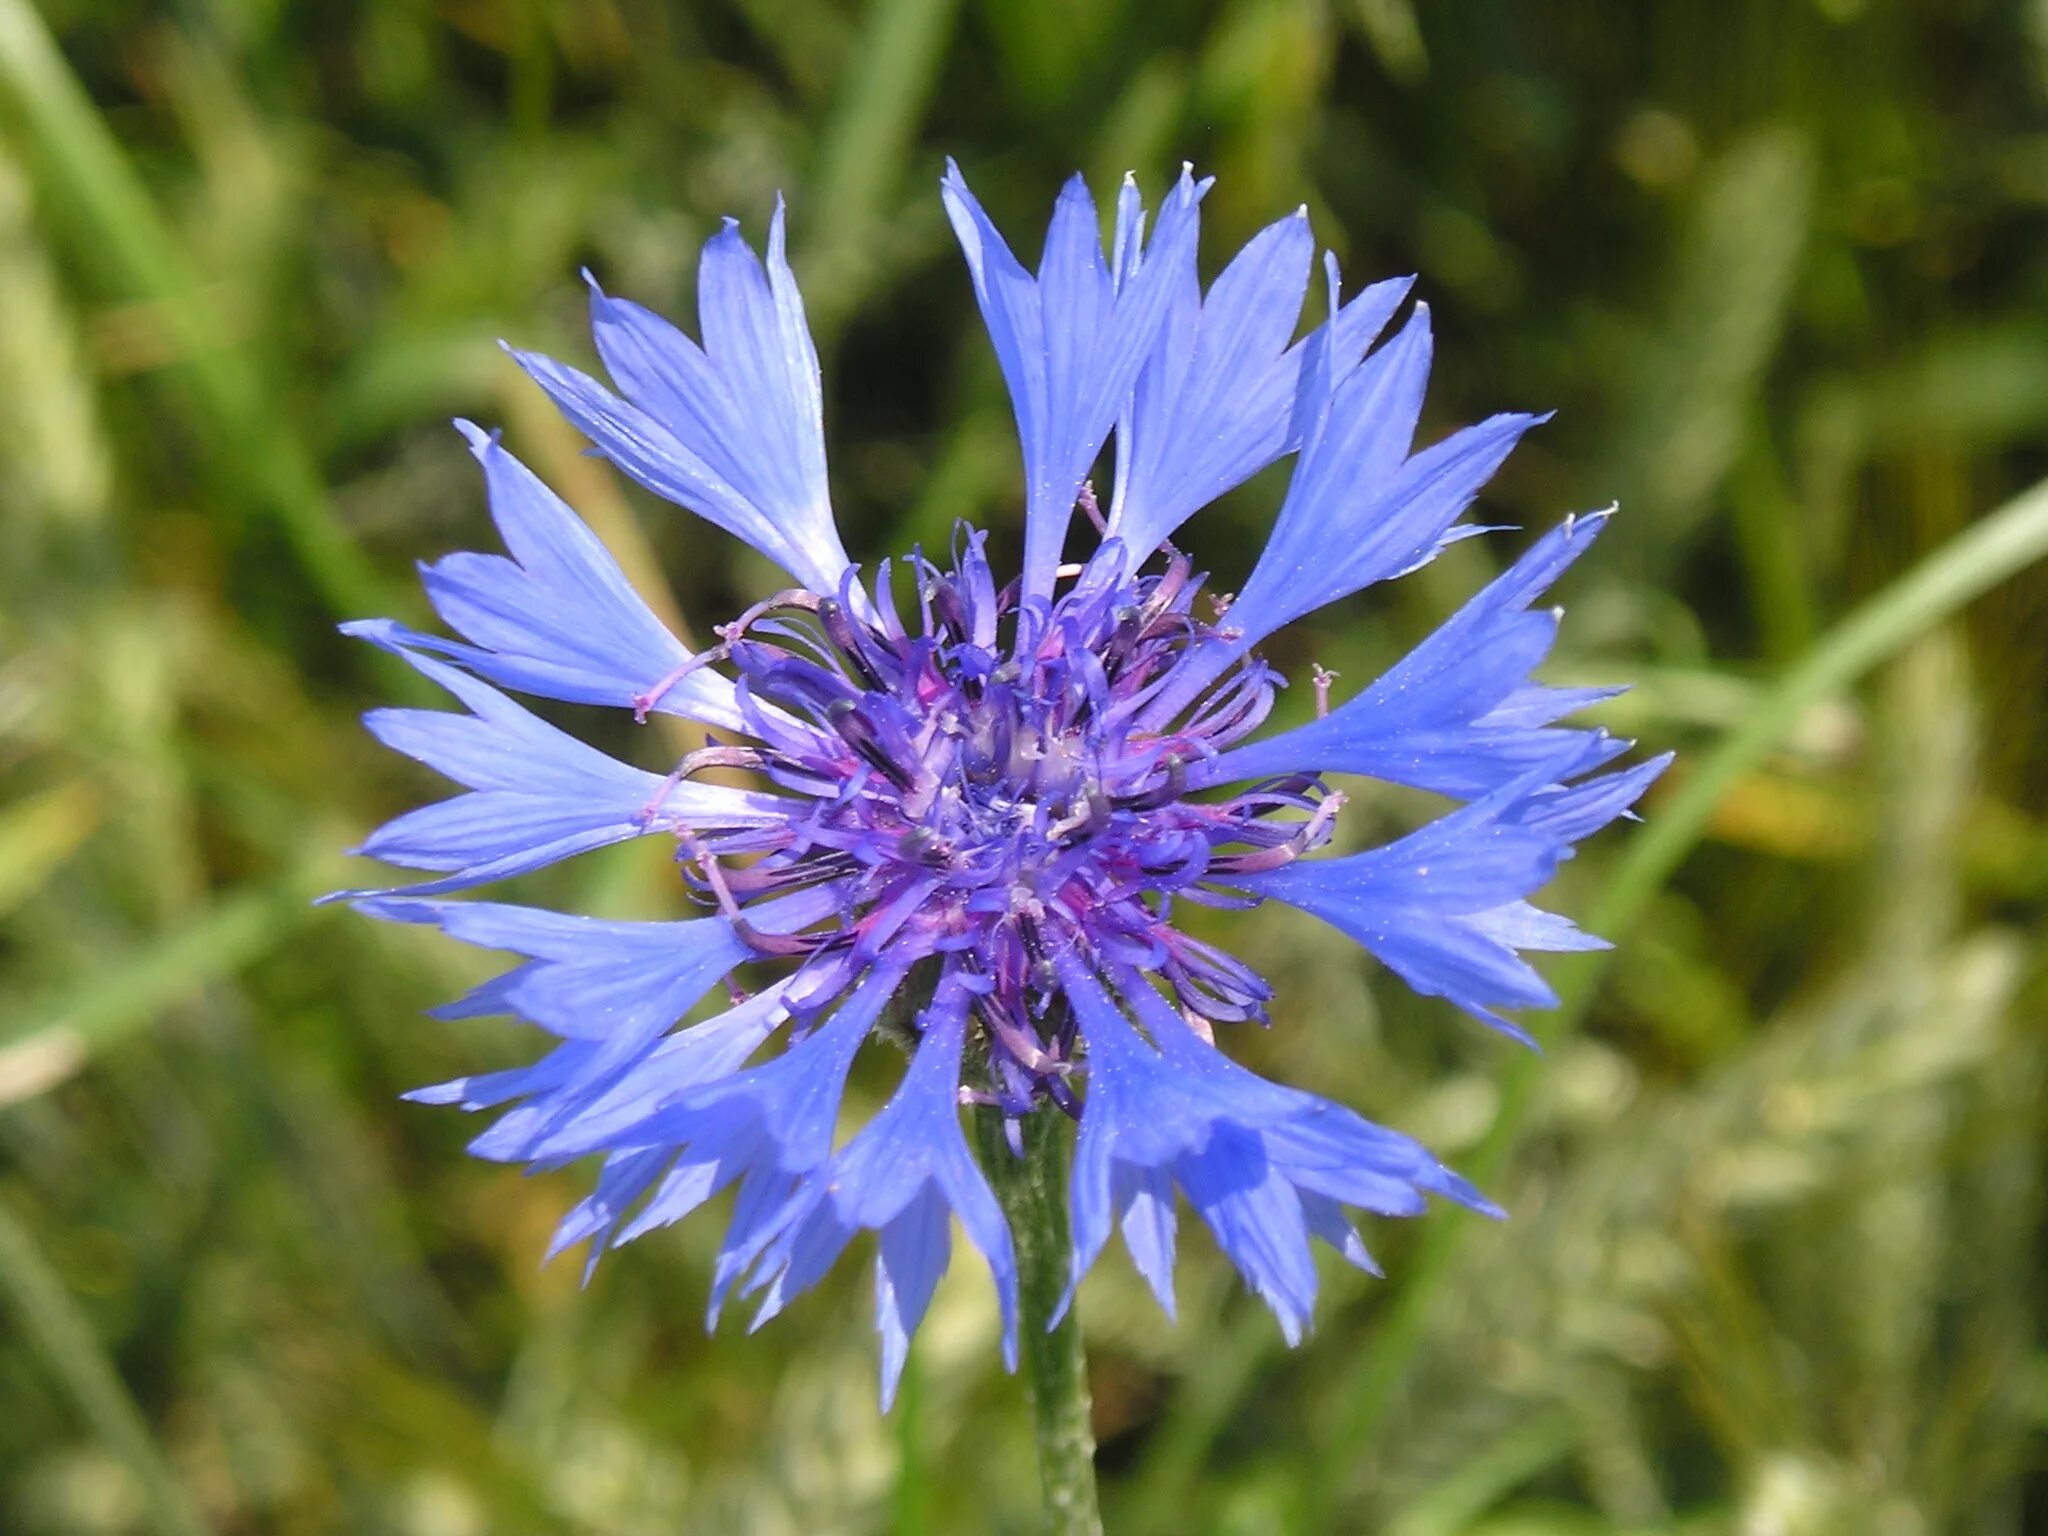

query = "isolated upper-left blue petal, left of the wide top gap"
(512, 203), (848, 592)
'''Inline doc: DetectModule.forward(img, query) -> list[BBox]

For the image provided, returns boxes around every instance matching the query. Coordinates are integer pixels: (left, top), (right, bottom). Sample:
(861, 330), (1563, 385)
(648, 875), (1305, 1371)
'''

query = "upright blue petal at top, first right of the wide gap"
(942, 162), (1208, 598)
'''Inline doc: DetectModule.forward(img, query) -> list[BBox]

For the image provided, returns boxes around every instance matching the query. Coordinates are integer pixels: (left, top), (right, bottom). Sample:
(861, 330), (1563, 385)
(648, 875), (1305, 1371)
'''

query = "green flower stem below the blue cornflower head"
(973, 1110), (1102, 1536)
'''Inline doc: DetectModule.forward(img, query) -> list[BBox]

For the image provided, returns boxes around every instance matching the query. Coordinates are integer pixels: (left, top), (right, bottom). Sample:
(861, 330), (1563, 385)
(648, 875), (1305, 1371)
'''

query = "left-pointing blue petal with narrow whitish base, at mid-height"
(330, 645), (786, 899)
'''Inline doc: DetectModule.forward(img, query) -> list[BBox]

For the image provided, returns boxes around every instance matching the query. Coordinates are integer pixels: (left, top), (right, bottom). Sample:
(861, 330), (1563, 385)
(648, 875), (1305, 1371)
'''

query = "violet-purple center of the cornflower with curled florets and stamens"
(641, 526), (1343, 1112)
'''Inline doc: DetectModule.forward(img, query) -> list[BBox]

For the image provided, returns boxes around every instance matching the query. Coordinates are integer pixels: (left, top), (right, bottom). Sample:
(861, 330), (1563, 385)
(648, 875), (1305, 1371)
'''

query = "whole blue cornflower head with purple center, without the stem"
(348, 170), (1663, 1401)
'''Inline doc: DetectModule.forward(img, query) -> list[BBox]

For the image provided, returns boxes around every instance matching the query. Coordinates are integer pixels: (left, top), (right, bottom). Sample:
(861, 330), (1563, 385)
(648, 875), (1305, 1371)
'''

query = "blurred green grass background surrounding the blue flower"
(0, 0), (2048, 1536)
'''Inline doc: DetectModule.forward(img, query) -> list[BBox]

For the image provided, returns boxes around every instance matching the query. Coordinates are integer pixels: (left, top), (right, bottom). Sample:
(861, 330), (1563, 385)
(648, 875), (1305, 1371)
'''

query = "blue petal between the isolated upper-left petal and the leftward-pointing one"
(362, 422), (743, 731)
